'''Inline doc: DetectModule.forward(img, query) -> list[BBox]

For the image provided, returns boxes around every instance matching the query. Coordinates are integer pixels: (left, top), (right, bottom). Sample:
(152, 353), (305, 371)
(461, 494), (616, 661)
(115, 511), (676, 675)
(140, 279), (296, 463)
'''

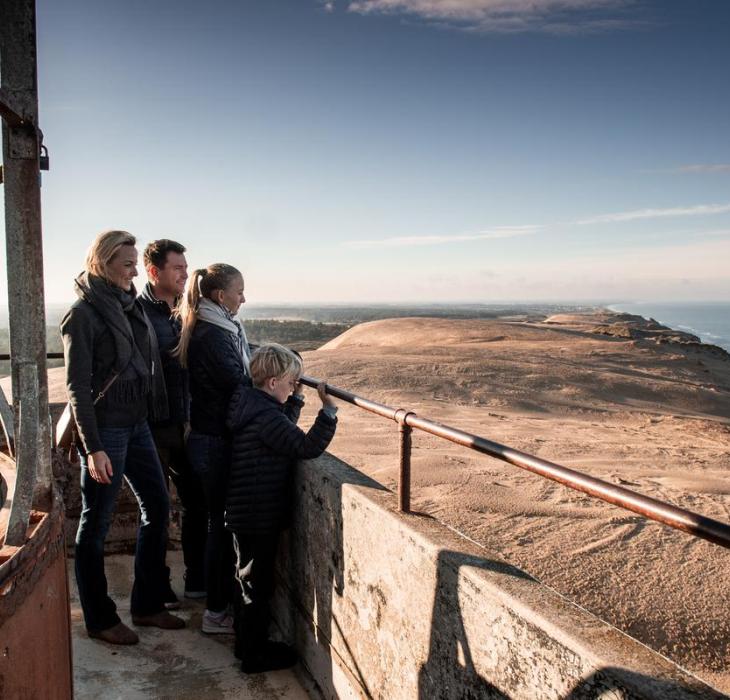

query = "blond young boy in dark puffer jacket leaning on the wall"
(225, 344), (337, 673)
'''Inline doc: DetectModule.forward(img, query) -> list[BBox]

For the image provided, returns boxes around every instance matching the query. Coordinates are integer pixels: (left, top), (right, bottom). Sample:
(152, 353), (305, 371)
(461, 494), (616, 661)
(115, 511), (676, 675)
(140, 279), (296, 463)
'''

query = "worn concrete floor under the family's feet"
(69, 552), (314, 700)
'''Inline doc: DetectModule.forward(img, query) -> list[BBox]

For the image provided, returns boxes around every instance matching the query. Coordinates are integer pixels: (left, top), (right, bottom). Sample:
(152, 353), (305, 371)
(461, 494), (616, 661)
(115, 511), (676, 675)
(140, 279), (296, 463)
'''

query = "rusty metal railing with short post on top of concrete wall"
(301, 376), (730, 549)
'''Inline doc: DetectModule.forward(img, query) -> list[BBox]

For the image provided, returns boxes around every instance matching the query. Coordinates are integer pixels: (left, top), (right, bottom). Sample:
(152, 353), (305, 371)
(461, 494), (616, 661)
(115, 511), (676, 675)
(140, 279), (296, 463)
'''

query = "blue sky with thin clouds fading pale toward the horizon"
(0, 0), (730, 304)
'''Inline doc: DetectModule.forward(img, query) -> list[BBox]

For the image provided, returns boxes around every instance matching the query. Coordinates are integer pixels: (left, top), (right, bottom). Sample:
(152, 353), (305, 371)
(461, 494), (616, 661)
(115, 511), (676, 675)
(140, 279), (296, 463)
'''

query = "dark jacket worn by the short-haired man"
(139, 283), (190, 425)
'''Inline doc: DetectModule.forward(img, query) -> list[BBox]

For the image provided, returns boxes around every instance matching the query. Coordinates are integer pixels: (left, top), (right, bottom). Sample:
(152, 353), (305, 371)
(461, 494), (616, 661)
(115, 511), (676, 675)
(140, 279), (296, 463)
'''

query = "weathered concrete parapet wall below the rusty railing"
(275, 456), (725, 700)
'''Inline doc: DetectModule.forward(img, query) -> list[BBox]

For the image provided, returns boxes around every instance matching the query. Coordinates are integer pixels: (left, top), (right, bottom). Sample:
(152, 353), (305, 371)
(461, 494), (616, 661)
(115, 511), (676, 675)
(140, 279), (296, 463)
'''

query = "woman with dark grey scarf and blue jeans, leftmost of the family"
(61, 231), (185, 644)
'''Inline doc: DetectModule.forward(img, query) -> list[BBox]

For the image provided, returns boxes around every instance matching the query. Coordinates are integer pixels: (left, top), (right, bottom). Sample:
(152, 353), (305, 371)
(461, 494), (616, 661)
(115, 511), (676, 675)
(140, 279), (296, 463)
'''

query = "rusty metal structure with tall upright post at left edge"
(0, 0), (73, 700)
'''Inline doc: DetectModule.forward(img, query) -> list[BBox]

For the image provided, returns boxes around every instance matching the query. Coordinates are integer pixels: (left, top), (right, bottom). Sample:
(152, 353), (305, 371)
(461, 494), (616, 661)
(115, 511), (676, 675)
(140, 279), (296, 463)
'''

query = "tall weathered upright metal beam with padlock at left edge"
(0, 0), (51, 537)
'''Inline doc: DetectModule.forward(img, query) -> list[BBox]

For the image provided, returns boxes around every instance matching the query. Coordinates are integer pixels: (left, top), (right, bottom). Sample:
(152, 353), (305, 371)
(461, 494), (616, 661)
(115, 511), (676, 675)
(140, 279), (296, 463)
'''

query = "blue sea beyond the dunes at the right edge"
(608, 301), (730, 352)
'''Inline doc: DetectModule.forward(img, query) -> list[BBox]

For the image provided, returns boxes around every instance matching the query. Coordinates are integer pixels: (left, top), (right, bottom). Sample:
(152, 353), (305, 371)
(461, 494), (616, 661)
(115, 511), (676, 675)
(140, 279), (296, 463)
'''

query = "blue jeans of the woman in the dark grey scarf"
(76, 421), (170, 632)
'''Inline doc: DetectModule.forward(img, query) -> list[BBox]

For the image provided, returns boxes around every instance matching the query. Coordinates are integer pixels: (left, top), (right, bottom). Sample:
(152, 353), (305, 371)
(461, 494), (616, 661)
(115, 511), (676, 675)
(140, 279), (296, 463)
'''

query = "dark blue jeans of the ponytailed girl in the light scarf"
(187, 430), (234, 612)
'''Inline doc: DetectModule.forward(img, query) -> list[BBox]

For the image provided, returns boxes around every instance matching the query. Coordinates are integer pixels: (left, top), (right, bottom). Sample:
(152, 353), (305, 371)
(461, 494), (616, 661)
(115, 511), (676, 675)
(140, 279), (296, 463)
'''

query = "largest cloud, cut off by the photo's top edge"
(340, 0), (637, 34)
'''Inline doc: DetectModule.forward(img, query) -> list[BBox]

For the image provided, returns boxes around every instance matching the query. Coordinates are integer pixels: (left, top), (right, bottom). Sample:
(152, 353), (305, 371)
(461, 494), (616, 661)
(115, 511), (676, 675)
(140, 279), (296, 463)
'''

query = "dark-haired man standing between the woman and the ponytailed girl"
(139, 238), (208, 609)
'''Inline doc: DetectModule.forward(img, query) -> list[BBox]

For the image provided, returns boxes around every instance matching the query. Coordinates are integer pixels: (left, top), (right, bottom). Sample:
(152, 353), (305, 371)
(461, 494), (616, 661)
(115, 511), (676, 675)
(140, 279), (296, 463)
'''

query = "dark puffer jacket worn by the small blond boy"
(225, 385), (337, 535)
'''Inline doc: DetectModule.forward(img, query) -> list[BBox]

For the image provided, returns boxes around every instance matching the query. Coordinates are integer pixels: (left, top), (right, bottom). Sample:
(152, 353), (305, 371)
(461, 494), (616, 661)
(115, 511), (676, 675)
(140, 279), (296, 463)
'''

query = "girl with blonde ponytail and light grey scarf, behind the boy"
(178, 263), (250, 634)
